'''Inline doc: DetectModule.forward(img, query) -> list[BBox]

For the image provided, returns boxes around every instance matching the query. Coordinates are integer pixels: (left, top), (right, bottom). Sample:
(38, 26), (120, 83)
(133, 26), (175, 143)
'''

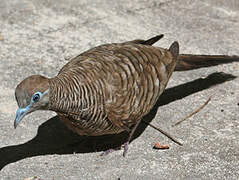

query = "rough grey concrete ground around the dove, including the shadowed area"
(0, 0), (239, 180)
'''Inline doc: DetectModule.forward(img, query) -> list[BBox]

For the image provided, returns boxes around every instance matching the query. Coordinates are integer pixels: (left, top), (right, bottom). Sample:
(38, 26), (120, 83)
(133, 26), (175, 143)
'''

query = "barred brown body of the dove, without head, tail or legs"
(50, 42), (178, 135)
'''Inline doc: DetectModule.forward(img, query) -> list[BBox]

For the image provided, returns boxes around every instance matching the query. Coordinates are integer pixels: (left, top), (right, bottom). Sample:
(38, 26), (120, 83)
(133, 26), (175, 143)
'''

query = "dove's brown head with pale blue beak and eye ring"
(14, 75), (49, 128)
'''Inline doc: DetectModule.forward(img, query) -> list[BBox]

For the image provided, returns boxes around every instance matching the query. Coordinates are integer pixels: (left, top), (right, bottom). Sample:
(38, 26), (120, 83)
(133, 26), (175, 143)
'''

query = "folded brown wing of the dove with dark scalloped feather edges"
(102, 44), (176, 127)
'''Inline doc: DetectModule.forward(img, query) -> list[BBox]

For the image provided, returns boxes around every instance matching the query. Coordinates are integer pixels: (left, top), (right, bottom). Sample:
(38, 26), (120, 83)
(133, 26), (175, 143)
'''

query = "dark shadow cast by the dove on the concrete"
(0, 73), (236, 170)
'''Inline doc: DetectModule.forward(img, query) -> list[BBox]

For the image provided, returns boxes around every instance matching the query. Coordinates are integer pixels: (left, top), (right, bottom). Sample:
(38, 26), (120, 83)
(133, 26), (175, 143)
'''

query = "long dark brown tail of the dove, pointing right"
(175, 54), (239, 71)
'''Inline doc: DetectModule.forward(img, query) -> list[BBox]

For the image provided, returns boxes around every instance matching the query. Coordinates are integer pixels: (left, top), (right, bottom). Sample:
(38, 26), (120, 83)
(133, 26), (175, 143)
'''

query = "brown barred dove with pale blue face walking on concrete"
(14, 34), (238, 156)
